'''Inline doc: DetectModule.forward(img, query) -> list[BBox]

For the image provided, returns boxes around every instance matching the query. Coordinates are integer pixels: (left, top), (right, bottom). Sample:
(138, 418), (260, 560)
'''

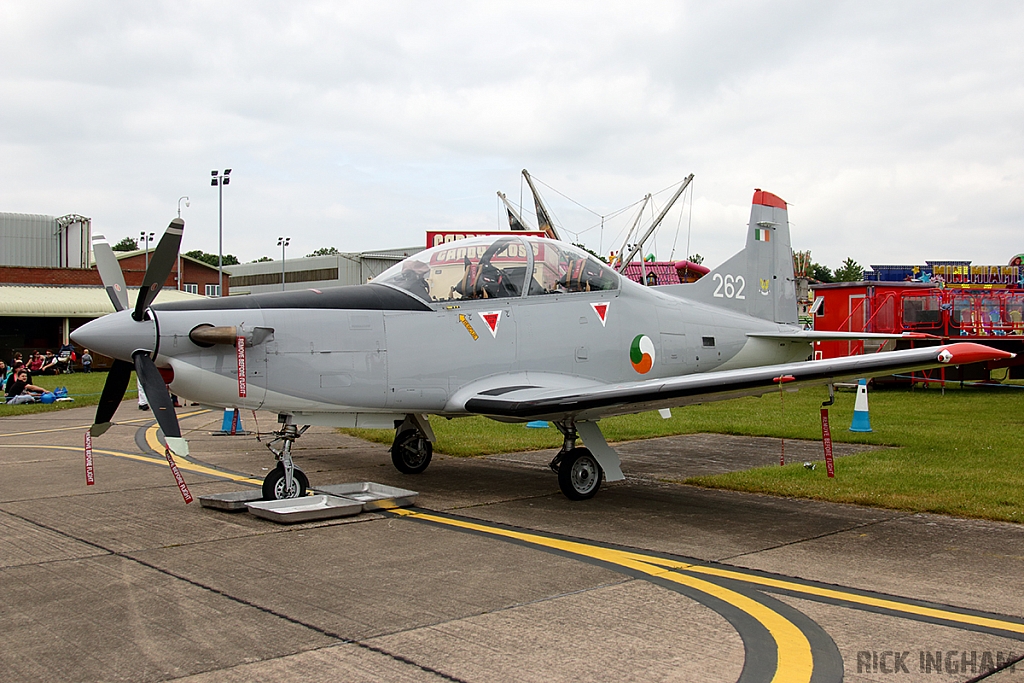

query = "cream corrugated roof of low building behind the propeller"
(0, 285), (206, 317)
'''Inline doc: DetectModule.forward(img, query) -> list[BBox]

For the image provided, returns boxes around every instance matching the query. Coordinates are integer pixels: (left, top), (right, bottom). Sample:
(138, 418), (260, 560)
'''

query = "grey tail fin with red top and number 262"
(678, 189), (797, 324)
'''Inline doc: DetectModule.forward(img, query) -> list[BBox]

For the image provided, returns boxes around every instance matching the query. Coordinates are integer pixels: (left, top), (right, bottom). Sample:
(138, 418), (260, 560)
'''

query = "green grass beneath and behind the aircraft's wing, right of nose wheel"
(347, 387), (1024, 522)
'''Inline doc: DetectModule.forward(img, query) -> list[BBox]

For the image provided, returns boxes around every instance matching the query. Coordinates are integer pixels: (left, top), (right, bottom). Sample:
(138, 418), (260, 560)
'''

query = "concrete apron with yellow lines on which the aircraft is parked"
(0, 403), (1024, 682)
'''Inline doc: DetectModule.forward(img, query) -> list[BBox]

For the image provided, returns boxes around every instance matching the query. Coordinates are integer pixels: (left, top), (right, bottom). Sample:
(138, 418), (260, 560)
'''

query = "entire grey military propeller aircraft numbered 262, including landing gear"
(72, 190), (1010, 500)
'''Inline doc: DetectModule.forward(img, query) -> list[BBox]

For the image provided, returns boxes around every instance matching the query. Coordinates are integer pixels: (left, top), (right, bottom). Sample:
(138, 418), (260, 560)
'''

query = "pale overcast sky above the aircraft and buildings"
(0, 0), (1024, 267)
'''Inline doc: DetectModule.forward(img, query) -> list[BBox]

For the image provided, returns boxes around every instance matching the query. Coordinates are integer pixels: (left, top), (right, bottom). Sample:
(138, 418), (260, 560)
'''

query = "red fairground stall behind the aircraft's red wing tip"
(811, 282), (1024, 382)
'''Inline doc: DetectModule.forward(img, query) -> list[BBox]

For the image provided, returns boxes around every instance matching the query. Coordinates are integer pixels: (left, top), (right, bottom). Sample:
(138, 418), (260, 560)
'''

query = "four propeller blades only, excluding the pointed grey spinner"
(89, 218), (188, 456)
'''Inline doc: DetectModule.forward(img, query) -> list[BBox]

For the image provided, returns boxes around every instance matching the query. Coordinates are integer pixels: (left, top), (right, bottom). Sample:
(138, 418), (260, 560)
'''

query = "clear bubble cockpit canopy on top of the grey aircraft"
(371, 233), (618, 301)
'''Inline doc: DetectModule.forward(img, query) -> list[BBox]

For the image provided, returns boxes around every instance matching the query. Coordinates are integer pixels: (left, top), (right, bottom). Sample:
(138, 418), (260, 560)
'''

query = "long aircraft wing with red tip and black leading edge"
(465, 342), (1014, 421)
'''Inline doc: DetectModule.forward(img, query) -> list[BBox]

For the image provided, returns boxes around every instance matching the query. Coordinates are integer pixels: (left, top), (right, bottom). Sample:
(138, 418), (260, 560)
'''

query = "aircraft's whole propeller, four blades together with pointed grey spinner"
(72, 218), (188, 456)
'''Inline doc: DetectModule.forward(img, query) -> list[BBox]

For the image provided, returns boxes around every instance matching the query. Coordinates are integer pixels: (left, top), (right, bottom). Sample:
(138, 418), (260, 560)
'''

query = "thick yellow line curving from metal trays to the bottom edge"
(392, 509), (814, 682)
